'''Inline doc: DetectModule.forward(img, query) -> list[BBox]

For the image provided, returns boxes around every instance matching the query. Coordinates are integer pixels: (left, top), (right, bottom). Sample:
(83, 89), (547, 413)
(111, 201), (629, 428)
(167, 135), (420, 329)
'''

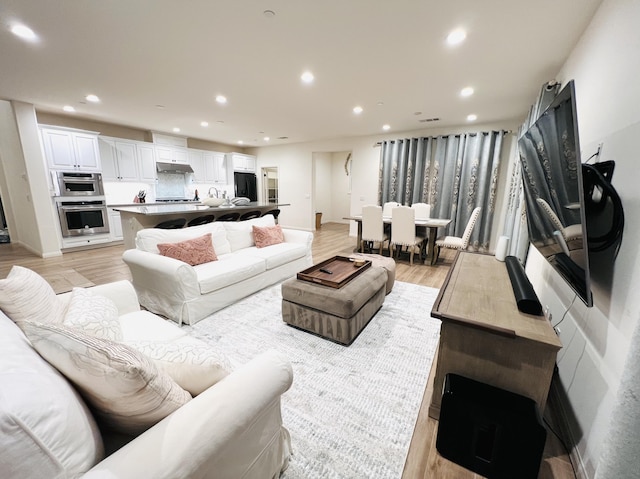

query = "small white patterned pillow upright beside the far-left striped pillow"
(63, 288), (122, 341)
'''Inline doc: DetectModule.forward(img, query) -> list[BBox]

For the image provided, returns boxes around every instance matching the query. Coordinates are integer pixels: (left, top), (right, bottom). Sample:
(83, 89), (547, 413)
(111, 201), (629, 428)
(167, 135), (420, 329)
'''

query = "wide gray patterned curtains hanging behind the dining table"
(378, 131), (505, 250)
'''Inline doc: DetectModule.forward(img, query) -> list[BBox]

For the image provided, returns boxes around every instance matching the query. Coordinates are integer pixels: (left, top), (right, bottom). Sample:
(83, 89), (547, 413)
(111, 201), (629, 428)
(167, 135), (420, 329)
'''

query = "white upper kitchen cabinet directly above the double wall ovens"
(40, 125), (101, 172)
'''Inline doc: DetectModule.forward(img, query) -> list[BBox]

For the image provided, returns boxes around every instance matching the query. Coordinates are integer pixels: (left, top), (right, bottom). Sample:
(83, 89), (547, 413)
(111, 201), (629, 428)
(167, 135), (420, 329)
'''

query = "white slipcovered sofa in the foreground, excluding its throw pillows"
(0, 281), (293, 479)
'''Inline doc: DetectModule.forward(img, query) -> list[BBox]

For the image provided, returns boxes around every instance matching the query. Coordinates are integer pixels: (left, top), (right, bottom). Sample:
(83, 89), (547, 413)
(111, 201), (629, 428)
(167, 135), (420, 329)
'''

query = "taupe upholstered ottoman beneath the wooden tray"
(282, 267), (387, 346)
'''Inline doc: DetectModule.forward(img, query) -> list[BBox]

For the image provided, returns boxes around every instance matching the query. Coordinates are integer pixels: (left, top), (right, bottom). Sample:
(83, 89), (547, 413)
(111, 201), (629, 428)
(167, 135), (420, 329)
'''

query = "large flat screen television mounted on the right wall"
(518, 81), (593, 306)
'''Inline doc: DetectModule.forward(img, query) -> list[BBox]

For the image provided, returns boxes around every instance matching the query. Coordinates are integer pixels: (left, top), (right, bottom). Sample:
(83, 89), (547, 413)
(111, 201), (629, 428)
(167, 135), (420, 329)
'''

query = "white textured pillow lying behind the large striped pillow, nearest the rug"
(127, 337), (231, 396)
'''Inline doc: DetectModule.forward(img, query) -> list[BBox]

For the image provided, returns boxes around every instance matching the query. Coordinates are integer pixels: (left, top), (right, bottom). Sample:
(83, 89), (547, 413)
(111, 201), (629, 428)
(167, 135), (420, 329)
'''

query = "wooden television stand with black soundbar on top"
(429, 251), (562, 419)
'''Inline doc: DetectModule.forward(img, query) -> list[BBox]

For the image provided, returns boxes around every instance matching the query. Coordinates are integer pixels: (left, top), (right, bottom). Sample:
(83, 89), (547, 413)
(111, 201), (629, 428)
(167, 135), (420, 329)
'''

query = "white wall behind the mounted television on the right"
(527, 0), (640, 477)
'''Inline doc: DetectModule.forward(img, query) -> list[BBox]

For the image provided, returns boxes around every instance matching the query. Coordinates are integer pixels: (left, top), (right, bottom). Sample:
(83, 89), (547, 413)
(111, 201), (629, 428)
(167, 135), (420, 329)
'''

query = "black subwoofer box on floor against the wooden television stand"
(436, 374), (547, 479)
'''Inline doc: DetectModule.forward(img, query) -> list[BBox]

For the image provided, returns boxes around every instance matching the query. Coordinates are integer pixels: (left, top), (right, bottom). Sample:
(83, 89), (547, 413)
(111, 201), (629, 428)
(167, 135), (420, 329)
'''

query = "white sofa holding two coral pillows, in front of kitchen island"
(122, 215), (313, 325)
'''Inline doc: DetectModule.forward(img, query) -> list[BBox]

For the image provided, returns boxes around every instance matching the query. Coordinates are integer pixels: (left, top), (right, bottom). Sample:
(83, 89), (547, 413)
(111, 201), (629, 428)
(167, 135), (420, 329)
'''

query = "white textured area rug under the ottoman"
(186, 281), (440, 479)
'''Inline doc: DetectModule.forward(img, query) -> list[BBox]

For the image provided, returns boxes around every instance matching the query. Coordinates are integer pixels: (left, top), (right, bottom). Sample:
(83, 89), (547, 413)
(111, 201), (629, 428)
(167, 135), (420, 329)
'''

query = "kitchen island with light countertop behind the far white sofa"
(111, 201), (288, 249)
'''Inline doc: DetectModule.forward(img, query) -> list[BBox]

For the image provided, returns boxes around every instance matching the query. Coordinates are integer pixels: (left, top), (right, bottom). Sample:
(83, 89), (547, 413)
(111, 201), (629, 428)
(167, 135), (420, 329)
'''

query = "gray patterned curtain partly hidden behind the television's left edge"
(502, 83), (560, 263)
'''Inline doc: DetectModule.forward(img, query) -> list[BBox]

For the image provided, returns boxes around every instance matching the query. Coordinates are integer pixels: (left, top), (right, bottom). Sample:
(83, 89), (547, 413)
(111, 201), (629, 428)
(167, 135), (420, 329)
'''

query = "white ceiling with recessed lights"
(0, 0), (601, 147)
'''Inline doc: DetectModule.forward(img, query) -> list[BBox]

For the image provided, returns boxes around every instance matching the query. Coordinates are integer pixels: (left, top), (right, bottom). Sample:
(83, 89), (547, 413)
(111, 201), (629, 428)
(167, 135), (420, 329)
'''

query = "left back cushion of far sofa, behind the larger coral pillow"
(136, 221), (231, 256)
